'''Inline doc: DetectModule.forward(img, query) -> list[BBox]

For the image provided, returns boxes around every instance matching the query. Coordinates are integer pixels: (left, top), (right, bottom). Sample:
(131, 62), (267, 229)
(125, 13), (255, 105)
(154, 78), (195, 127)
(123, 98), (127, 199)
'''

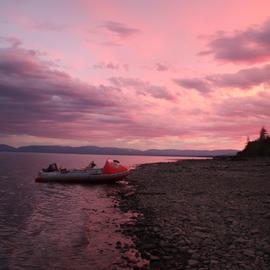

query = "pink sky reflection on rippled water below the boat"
(6, 185), (126, 269)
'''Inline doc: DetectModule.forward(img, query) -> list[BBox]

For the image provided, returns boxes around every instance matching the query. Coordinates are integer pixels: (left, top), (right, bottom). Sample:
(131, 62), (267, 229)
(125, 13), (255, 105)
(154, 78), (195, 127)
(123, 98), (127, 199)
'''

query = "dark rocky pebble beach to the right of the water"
(117, 159), (270, 270)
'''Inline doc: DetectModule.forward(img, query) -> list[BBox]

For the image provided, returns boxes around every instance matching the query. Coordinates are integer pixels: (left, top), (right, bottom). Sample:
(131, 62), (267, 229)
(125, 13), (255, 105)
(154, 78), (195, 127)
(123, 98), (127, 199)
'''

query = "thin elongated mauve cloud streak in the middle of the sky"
(110, 77), (176, 100)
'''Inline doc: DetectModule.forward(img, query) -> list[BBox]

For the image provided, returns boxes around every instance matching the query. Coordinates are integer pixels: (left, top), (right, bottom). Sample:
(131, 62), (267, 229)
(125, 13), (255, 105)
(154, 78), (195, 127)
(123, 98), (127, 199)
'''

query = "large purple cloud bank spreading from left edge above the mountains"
(0, 44), (179, 140)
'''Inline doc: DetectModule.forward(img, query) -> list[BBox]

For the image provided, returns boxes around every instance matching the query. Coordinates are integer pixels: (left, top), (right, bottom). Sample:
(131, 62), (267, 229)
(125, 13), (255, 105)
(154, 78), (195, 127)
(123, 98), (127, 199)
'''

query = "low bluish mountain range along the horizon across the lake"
(0, 144), (237, 157)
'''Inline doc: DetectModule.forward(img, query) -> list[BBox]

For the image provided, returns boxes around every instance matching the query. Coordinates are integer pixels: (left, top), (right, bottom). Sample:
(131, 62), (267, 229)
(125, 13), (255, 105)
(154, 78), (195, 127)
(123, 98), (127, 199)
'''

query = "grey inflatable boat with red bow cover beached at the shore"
(36, 159), (129, 184)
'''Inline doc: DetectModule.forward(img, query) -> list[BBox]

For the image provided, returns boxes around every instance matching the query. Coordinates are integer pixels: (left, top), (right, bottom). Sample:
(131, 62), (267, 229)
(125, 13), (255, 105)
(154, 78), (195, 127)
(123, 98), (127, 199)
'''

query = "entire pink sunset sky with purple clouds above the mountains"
(0, 0), (270, 150)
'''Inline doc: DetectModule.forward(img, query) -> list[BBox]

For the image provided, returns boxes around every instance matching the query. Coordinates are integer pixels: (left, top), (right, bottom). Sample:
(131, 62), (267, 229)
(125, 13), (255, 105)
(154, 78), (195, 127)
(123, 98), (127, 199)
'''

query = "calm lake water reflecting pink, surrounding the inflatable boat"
(0, 153), (197, 270)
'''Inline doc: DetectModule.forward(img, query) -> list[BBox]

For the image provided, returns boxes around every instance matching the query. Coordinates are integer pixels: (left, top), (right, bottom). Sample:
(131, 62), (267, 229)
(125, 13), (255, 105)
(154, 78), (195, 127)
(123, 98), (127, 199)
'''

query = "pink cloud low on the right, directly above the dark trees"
(197, 91), (270, 141)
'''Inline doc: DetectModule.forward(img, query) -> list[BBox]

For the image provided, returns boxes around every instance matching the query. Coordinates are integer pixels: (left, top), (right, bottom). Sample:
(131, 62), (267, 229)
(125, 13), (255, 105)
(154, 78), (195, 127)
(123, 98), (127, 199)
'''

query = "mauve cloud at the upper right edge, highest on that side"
(200, 20), (270, 63)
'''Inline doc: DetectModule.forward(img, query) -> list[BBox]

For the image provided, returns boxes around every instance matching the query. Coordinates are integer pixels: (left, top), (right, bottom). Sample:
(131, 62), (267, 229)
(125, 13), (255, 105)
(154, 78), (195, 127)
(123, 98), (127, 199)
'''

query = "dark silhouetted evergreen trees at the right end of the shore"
(237, 127), (270, 157)
